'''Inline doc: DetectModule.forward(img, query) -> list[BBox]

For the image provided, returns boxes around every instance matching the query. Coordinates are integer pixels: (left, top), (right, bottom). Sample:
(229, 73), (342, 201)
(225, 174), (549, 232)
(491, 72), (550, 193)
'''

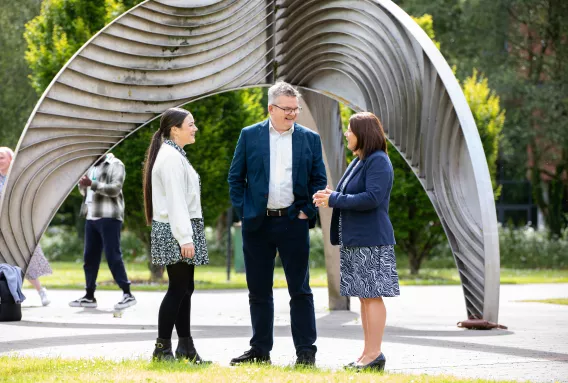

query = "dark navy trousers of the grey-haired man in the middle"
(243, 216), (317, 354)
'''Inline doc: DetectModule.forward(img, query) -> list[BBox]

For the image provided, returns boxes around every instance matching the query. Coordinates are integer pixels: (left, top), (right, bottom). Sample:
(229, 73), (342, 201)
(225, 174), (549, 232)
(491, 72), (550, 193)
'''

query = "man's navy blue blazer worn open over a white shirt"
(229, 120), (327, 231)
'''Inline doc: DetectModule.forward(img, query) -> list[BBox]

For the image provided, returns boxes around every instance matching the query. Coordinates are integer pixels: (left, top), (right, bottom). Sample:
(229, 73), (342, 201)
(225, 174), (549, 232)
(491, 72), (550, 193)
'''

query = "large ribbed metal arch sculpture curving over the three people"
(0, 0), (499, 322)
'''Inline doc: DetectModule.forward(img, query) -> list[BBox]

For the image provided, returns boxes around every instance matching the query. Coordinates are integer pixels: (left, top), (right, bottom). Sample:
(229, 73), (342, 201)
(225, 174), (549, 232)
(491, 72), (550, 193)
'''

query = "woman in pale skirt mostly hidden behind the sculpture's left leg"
(0, 146), (52, 306)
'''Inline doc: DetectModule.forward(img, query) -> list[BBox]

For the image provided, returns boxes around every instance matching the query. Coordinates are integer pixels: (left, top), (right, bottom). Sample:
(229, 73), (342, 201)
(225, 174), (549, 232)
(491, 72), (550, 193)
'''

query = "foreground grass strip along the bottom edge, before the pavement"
(0, 356), (528, 383)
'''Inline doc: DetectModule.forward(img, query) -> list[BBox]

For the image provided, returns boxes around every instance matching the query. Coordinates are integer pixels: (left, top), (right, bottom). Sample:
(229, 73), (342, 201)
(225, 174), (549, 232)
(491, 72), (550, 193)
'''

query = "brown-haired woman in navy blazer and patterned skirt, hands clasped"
(314, 112), (399, 371)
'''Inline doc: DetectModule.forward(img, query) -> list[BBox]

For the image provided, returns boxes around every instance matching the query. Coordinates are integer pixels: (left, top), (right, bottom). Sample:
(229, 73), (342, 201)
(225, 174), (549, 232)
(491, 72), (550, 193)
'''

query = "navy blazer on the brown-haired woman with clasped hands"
(329, 150), (396, 246)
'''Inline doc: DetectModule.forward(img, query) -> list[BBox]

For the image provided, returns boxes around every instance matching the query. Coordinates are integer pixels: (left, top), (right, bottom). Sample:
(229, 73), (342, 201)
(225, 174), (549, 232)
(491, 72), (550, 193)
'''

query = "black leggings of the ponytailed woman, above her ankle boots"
(158, 262), (195, 339)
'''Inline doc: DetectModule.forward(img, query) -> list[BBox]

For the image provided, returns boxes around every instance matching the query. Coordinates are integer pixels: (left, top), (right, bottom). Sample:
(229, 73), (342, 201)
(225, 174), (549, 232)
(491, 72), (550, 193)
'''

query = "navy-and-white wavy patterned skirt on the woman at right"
(339, 245), (400, 298)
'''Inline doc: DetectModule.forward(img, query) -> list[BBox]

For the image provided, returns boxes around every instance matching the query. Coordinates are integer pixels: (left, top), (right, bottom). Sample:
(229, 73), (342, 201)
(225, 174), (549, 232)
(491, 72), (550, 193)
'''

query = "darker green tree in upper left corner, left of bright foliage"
(0, 0), (41, 149)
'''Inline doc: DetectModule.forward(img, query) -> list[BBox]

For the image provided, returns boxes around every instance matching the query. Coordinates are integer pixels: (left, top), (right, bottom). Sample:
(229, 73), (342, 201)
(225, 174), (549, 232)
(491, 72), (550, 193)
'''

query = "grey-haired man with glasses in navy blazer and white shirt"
(229, 82), (326, 365)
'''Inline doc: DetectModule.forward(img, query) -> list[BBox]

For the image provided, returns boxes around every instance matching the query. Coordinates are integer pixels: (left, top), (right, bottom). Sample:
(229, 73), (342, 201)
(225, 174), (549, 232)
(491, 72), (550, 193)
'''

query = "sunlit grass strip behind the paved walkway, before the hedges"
(30, 261), (568, 291)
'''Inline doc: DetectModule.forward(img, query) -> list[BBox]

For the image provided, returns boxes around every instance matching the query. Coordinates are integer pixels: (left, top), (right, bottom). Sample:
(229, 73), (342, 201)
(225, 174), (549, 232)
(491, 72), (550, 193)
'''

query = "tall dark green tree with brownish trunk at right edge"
(499, 0), (568, 238)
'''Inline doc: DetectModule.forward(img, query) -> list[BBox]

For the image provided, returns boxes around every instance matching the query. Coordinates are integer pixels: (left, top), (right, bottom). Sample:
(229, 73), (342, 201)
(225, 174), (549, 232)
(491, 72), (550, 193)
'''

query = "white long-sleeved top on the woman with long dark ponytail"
(152, 144), (203, 246)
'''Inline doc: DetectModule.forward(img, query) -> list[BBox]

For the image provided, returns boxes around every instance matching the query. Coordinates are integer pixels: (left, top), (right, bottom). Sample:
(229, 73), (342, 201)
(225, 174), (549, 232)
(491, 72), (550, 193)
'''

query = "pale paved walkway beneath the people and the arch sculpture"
(0, 284), (568, 382)
